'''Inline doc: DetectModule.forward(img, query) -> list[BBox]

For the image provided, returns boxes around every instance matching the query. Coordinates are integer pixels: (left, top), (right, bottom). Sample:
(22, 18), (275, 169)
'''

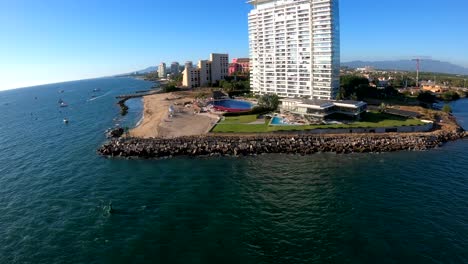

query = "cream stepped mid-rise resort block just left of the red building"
(182, 53), (229, 88)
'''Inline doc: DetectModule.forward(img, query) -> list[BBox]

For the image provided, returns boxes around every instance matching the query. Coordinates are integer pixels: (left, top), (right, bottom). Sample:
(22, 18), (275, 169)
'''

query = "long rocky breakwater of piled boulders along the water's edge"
(98, 131), (467, 158)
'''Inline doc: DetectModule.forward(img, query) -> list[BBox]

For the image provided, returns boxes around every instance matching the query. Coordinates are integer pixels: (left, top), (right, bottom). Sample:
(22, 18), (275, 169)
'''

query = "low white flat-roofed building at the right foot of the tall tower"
(280, 98), (367, 120)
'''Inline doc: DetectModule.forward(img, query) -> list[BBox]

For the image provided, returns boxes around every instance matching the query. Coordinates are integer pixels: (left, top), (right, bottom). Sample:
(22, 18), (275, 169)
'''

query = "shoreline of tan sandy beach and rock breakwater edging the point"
(103, 91), (468, 159)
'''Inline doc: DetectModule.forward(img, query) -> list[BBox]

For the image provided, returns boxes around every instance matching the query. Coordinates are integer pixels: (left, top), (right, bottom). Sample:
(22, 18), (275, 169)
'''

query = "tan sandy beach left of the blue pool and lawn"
(130, 93), (219, 138)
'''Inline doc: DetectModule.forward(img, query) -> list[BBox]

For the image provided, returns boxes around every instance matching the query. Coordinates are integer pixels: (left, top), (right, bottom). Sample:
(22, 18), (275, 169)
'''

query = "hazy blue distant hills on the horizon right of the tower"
(341, 60), (468, 74)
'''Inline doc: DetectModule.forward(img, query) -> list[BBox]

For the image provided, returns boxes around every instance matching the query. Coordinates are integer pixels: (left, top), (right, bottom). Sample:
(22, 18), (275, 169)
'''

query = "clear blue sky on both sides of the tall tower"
(0, 0), (468, 90)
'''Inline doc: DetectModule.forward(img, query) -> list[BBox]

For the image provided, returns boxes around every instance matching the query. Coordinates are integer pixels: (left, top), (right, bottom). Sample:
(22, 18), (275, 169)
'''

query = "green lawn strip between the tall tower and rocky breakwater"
(212, 112), (424, 133)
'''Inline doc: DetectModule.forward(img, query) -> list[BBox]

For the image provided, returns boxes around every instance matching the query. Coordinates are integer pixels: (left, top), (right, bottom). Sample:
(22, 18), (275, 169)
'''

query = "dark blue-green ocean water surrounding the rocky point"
(0, 78), (468, 263)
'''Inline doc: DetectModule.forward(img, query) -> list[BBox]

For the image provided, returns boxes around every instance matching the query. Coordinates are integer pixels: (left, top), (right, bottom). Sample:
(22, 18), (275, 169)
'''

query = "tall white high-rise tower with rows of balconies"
(249, 0), (340, 99)
